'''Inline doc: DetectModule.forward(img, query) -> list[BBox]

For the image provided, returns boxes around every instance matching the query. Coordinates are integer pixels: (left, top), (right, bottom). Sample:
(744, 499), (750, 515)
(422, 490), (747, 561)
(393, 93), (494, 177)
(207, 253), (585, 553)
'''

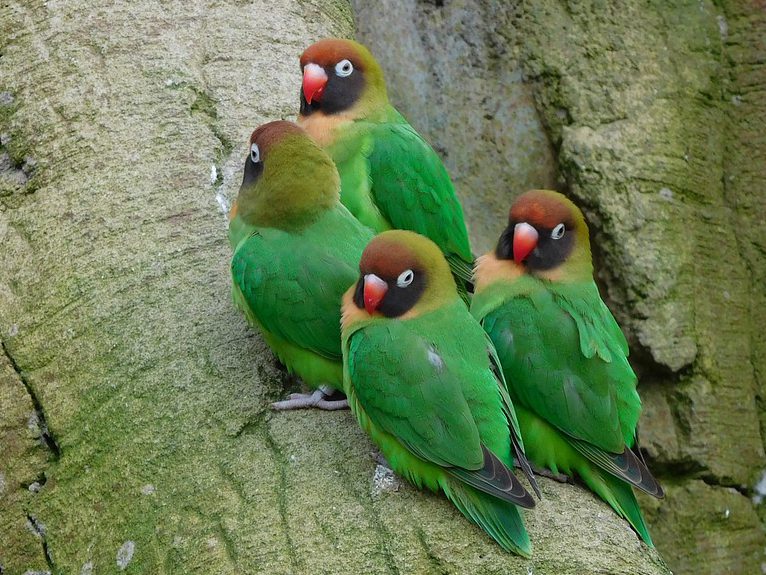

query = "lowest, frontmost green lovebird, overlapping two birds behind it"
(342, 230), (537, 556)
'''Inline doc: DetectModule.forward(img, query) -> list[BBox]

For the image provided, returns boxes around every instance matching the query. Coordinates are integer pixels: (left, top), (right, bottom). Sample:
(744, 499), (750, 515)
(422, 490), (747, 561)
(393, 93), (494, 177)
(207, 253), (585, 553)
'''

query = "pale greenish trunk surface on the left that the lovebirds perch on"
(0, 0), (667, 575)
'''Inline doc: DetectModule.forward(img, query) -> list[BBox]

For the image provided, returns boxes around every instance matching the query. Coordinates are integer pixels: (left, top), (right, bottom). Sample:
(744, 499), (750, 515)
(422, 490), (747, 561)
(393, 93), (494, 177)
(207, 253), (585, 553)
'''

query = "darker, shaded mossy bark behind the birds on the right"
(353, 0), (766, 574)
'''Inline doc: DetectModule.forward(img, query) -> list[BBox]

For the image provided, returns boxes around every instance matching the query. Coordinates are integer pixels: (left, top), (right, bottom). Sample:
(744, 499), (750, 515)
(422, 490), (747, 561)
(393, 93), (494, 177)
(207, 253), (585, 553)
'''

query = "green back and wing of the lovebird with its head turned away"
(231, 206), (372, 360)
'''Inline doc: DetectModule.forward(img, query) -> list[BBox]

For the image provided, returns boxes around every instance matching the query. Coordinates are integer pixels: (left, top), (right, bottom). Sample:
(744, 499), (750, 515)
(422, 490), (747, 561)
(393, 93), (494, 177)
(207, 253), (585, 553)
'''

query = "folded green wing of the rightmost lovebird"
(482, 280), (640, 453)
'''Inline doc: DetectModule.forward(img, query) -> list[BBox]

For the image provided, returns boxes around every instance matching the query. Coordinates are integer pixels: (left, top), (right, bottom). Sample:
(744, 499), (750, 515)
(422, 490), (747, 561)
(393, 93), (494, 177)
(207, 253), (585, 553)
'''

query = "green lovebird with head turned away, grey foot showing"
(229, 121), (372, 409)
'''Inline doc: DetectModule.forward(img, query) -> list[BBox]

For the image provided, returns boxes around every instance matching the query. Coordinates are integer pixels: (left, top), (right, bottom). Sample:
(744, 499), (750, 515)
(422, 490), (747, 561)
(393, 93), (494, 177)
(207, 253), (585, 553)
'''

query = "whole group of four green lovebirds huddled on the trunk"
(229, 39), (663, 556)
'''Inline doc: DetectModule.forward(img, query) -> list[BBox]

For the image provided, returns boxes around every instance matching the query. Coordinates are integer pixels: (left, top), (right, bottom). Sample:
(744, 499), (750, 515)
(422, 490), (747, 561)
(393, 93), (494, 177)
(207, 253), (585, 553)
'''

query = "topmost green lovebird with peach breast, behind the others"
(298, 39), (473, 301)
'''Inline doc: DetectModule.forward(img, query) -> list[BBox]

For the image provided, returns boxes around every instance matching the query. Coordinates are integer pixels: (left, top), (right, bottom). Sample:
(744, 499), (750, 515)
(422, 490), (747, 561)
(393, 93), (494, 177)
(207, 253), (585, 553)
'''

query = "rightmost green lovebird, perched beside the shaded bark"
(471, 190), (663, 545)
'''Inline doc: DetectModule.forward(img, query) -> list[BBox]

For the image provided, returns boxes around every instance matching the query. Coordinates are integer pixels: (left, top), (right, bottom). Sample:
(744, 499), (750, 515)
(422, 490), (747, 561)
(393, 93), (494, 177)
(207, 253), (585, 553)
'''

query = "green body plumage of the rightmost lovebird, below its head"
(473, 282), (652, 545)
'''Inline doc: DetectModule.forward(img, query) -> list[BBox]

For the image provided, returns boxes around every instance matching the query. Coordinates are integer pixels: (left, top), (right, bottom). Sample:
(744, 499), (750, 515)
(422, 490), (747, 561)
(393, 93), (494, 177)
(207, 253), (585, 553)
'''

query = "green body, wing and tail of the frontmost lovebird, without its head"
(344, 302), (534, 557)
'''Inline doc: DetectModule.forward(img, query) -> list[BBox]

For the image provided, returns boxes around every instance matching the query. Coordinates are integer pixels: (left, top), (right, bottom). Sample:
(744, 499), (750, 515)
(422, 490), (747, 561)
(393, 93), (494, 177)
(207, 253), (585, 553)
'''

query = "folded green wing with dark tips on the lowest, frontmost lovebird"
(346, 303), (534, 507)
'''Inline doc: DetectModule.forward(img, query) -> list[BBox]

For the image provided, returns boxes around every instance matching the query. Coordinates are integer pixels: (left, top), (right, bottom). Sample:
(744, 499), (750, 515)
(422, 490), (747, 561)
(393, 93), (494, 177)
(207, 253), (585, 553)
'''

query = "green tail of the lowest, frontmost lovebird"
(444, 481), (532, 557)
